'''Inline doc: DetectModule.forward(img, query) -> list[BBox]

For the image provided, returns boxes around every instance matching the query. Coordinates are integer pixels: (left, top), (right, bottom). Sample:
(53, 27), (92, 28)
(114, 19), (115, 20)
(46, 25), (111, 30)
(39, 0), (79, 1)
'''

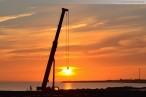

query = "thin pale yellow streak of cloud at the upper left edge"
(0, 12), (34, 22)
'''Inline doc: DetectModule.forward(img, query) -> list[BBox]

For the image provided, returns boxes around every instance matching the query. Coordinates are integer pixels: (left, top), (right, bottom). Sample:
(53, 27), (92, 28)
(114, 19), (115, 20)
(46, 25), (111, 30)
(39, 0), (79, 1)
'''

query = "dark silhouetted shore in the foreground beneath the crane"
(0, 87), (146, 97)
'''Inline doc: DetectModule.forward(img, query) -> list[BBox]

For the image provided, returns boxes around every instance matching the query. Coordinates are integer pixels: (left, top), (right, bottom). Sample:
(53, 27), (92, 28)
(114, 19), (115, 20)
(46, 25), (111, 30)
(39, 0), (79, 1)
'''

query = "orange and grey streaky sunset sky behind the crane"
(0, 0), (146, 81)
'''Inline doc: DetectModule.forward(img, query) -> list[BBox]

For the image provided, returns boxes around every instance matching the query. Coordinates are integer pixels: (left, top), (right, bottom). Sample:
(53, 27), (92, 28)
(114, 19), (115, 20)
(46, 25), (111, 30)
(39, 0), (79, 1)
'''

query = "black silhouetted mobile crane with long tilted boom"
(37, 8), (68, 91)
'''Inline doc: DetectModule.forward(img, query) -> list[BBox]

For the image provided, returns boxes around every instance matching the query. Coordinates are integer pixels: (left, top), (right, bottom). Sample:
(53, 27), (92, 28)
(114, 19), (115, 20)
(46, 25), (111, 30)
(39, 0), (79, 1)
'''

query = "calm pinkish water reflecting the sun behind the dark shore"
(0, 82), (146, 91)
